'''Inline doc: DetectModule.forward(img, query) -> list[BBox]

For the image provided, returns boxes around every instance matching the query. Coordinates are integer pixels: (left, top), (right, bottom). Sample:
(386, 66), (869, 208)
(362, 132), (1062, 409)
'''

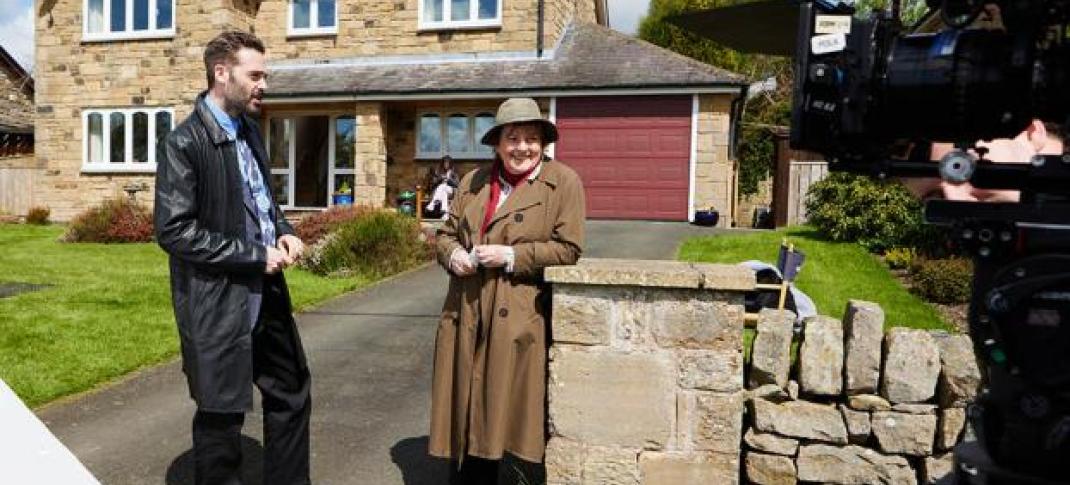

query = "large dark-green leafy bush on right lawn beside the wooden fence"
(806, 172), (937, 253)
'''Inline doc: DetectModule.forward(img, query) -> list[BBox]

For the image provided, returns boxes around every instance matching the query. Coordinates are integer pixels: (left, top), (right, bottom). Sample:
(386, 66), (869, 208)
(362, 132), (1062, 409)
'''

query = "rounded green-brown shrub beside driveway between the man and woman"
(304, 211), (430, 276)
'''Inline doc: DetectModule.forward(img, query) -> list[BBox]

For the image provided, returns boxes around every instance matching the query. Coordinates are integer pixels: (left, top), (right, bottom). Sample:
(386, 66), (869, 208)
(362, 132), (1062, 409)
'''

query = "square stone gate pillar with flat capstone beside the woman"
(546, 259), (753, 484)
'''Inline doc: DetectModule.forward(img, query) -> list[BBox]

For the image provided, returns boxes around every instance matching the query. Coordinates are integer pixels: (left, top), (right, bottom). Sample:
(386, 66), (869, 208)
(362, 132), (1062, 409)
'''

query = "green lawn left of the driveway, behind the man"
(0, 224), (370, 406)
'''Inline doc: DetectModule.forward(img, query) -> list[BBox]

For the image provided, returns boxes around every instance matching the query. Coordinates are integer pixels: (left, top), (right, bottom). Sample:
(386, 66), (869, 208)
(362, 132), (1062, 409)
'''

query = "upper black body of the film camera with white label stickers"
(791, 0), (1070, 171)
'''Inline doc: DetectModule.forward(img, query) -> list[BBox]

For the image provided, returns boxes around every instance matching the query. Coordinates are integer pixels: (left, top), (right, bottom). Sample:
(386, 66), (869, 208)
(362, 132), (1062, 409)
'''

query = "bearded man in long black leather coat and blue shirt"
(155, 32), (311, 484)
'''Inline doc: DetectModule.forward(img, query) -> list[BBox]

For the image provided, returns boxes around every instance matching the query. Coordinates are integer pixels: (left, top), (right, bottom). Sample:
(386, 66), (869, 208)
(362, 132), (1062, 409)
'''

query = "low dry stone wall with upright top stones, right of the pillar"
(744, 301), (980, 485)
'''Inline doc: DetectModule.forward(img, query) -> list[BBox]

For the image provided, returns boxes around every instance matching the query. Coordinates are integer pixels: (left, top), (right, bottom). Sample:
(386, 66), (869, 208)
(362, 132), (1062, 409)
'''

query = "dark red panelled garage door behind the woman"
(554, 96), (691, 221)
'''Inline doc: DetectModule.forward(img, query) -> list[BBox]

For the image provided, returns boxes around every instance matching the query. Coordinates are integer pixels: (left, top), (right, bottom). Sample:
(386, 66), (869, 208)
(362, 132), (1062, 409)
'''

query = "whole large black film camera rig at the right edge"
(672, 0), (1070, 484)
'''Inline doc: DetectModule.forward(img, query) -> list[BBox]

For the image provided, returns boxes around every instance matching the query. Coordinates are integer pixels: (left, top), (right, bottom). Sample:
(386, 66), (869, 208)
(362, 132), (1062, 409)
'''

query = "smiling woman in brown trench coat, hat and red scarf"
(430, 98), (586, 484)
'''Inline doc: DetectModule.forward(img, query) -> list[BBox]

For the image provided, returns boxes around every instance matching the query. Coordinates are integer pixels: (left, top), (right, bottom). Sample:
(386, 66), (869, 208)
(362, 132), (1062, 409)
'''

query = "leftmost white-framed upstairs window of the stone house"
(82, 0), (174, 41)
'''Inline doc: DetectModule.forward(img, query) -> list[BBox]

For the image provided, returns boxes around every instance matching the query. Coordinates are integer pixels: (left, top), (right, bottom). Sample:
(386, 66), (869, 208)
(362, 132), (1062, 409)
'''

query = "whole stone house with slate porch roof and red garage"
(34, 0), (744, 224)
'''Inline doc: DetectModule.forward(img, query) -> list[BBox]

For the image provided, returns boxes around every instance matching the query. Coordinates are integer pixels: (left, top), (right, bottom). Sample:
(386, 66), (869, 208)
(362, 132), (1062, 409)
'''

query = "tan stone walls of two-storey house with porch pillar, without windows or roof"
(33, 0), (595, 221)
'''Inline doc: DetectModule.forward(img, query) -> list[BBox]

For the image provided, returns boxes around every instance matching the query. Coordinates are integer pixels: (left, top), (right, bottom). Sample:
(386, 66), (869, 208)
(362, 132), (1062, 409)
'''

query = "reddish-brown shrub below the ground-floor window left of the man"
(63, 198), (153, 243)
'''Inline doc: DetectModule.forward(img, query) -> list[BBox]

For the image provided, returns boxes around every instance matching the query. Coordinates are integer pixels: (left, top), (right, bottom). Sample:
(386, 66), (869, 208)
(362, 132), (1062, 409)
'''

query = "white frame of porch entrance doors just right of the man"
(264, 112), (361, 211)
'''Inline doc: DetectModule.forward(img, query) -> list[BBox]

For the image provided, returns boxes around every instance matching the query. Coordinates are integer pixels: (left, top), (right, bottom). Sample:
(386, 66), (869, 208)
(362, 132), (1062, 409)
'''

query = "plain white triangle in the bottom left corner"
(0, 379), (101, 485)
